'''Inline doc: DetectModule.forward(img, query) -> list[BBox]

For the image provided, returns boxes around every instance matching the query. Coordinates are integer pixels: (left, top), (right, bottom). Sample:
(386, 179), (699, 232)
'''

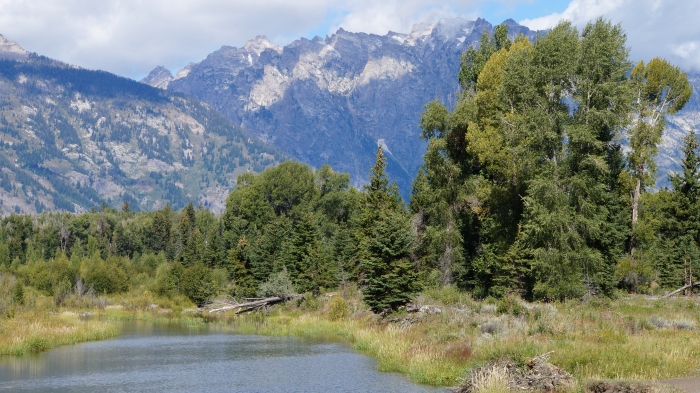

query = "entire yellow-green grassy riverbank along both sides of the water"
(0, 287), (700, 391)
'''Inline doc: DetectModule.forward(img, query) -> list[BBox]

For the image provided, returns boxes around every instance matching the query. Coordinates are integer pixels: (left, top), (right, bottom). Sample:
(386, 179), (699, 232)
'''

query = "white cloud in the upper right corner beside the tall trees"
(520, 0), (700, 71)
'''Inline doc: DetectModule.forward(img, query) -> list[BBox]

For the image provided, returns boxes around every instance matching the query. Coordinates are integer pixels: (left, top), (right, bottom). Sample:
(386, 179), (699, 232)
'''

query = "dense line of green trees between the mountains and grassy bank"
(0, 19), (700, 312)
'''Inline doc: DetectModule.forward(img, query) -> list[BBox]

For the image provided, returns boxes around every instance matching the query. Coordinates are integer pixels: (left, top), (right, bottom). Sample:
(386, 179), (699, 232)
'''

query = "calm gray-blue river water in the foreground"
(0, 321), (445, 393)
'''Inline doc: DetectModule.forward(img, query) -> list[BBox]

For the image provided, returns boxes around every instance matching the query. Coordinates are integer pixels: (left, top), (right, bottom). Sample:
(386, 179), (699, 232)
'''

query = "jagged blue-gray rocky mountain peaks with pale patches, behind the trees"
(152, 18), (537, 195)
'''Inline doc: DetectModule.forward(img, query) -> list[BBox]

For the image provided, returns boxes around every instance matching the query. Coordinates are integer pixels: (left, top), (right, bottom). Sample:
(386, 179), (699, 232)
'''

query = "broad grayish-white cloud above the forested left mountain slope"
(0, 0), (328, 77)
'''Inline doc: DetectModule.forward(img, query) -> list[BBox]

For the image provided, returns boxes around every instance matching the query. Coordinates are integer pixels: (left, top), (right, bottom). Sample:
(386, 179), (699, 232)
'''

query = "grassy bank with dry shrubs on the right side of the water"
(208, 288), (700, 386)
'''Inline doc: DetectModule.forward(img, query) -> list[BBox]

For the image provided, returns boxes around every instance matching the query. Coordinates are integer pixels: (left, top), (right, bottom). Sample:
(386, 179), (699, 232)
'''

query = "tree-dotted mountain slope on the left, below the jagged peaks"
(0, 37), (284, 215)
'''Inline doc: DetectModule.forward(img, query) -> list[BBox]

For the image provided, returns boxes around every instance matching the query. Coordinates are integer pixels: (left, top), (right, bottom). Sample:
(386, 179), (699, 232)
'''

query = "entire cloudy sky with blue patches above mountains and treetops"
(0, 0), (700, 79)
